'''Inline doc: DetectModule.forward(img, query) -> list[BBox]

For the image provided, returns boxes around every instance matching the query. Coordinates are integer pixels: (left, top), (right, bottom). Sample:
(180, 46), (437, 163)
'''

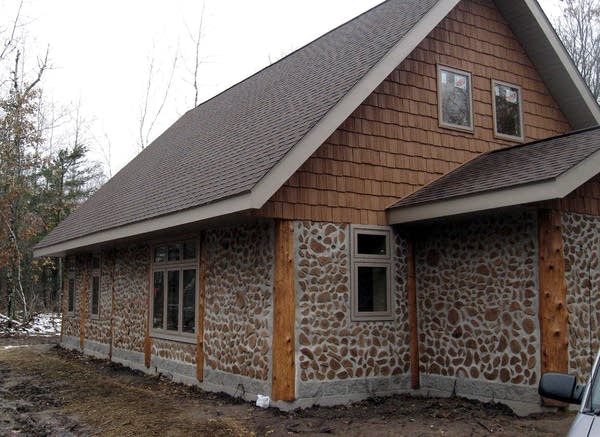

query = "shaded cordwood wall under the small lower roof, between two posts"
(416, 211), (540, 405)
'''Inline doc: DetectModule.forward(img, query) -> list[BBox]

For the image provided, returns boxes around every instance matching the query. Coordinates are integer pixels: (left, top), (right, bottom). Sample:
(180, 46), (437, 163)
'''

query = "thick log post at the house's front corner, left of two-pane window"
(271, 220), (296, 401)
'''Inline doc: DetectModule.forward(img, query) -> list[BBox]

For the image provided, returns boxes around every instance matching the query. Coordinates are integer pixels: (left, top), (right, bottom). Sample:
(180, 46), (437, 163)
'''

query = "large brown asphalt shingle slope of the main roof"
(37, 0), (438, 248)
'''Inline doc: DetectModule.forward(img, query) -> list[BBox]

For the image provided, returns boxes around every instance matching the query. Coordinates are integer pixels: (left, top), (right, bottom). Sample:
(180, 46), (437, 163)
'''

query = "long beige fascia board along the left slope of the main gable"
(252, 0), (460, 204)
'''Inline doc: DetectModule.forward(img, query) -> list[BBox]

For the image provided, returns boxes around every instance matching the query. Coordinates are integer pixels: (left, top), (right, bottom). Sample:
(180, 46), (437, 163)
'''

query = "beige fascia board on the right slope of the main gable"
(523, 0), (600, 124)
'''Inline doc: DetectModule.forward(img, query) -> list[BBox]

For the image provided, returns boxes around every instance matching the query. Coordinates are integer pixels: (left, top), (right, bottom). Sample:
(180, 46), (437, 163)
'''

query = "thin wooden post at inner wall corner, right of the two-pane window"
(407, 236), (420, 390)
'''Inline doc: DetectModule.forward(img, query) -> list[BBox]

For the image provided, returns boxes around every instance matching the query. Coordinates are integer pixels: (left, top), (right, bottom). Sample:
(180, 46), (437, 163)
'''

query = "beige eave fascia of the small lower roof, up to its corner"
(388, 179), (561, 225)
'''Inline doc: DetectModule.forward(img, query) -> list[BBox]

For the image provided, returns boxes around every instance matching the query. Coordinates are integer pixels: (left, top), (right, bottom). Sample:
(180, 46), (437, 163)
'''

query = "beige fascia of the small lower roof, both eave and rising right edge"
(388, 146), (600, 225)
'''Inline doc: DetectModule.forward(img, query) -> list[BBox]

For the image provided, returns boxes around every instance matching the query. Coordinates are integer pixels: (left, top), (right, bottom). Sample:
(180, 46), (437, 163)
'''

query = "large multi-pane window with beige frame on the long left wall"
(151, 241), (198, 336)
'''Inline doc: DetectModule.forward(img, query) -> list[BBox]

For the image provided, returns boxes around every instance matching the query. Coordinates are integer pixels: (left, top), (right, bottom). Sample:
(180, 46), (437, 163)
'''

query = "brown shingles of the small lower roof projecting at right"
(389, 127), (600, 209)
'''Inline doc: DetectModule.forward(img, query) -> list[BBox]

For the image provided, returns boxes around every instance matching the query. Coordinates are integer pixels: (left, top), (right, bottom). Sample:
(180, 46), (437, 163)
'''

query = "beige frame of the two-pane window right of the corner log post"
(350, 225), (394, 322)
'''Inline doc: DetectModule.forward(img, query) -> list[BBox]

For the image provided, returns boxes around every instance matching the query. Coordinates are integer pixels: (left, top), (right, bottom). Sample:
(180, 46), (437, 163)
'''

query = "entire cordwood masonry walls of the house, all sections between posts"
(62, 210), (600, 412)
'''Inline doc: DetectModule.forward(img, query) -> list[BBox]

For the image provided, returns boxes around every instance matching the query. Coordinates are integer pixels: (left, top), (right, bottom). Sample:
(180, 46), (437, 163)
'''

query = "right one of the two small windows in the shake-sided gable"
(492, 80), (524, 141)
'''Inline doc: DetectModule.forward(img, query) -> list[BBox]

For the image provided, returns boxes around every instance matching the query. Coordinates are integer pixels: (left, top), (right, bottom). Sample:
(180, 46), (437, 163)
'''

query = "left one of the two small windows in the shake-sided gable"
(438, 65), (473, 131)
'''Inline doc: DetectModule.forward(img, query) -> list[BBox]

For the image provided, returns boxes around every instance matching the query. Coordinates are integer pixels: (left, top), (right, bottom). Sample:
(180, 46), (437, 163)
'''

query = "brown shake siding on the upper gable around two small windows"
(258, 0), (570, 225)
